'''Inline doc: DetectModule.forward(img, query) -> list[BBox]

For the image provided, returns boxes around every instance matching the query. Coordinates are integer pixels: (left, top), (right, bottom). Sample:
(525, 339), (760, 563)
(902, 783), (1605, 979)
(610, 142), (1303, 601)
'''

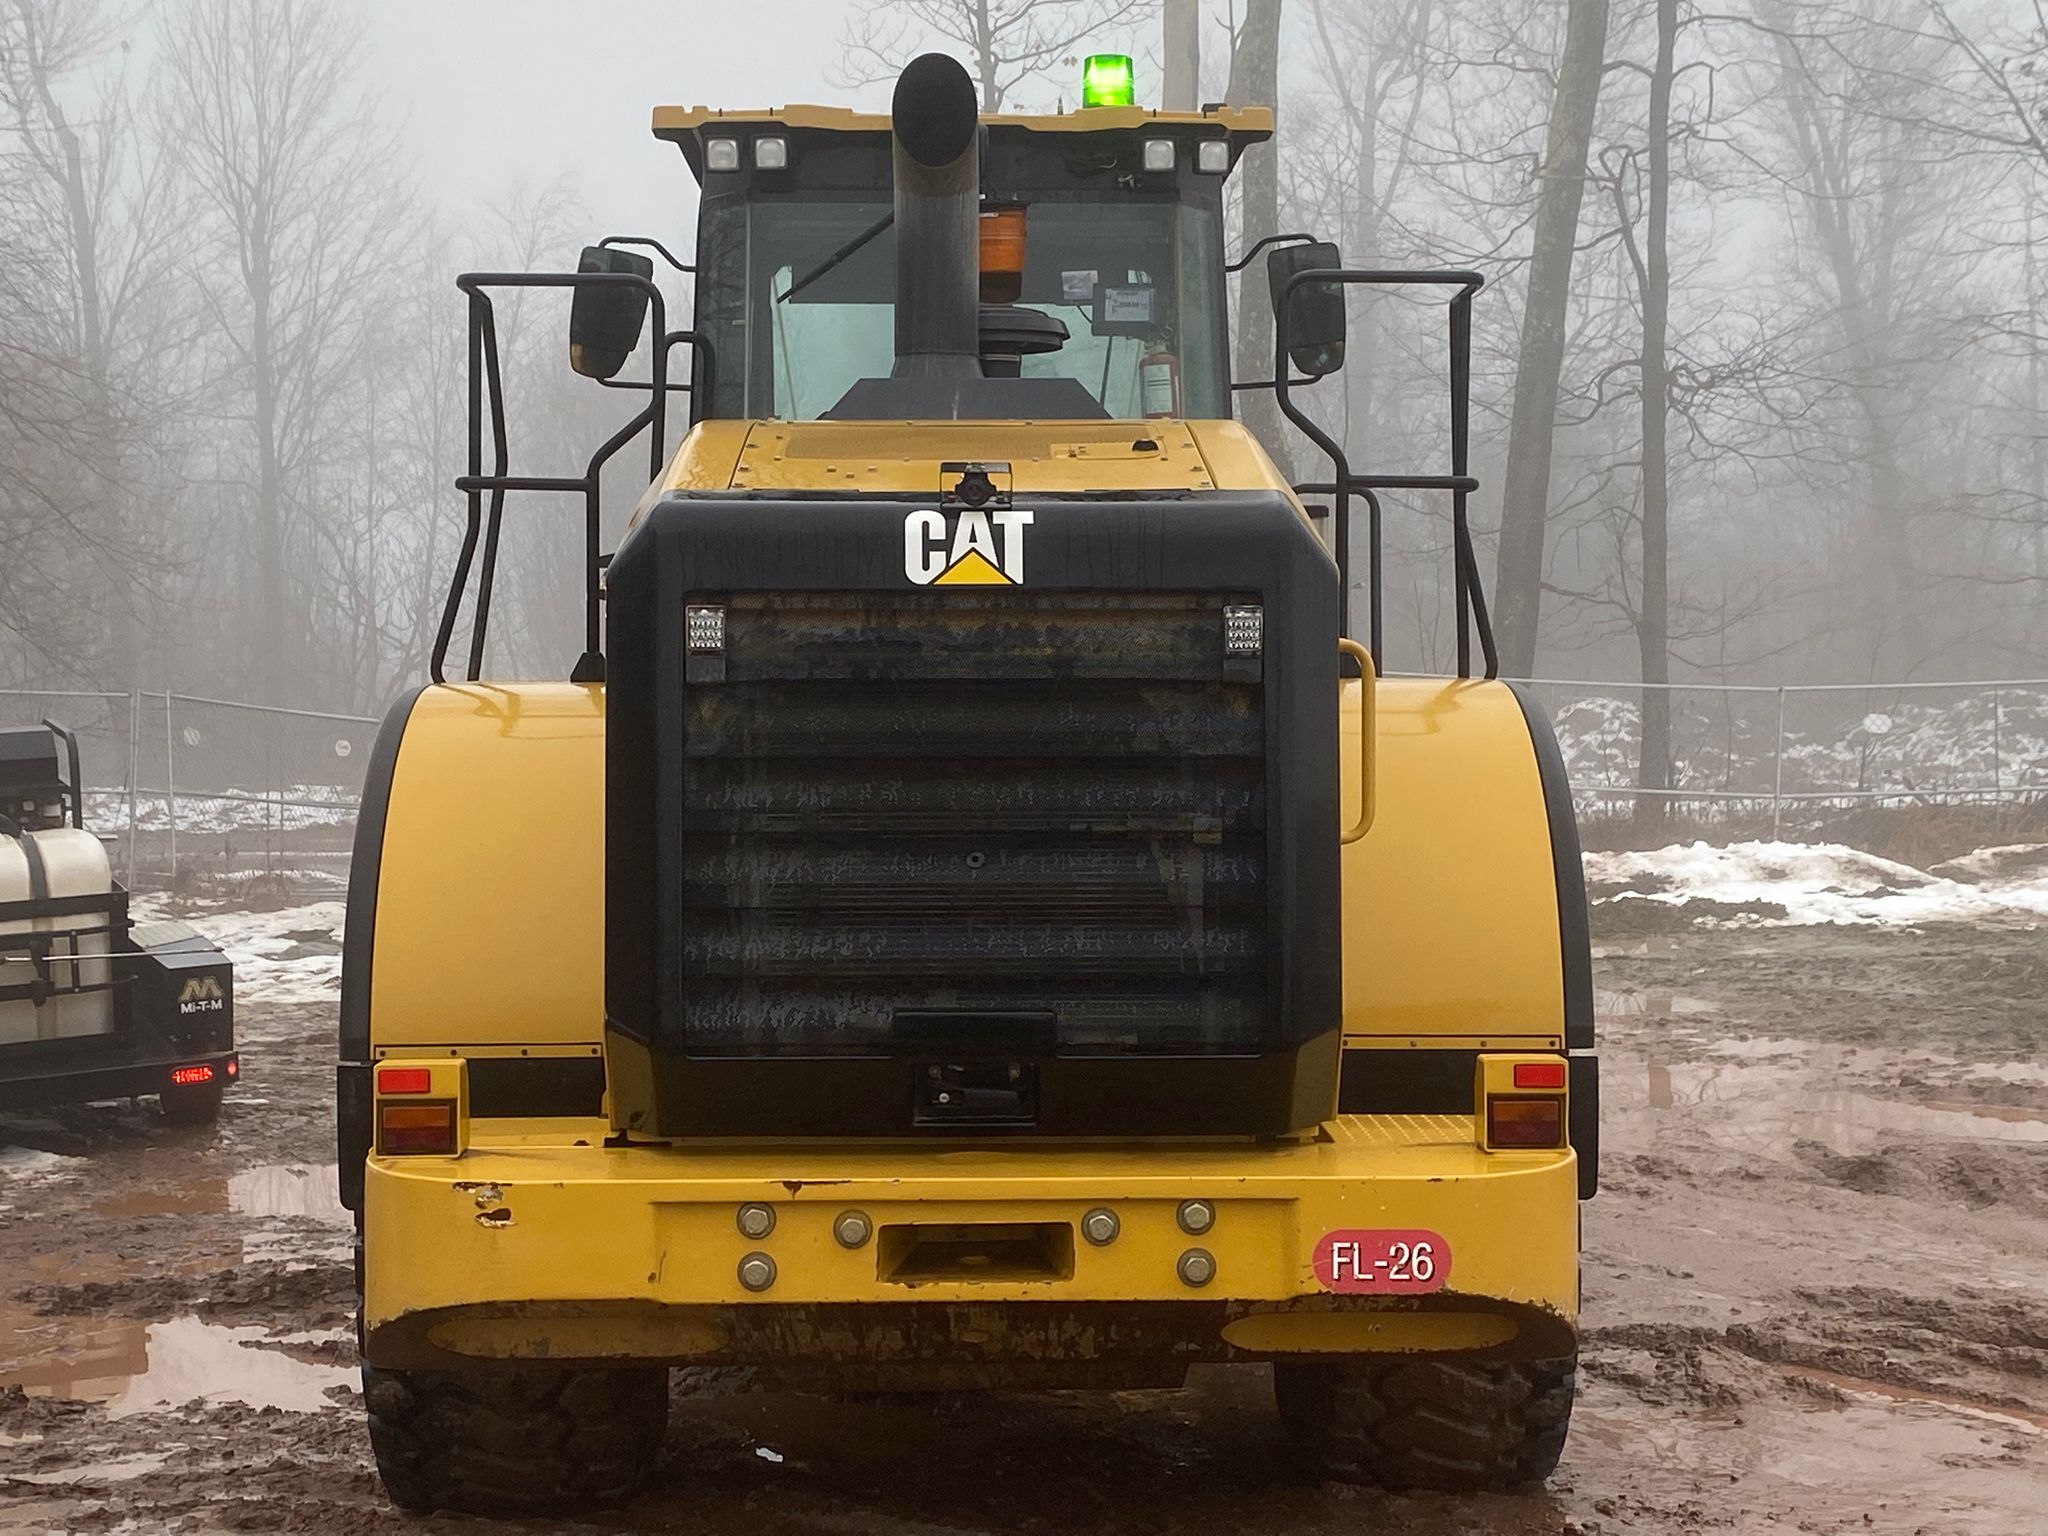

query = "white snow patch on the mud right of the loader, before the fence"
(1585, 842), (2048, 928)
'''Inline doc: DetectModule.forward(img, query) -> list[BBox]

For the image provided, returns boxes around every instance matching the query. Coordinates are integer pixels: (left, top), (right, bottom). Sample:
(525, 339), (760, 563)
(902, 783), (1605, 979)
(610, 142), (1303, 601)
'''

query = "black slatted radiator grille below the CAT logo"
(678, 588), (1268, 1053)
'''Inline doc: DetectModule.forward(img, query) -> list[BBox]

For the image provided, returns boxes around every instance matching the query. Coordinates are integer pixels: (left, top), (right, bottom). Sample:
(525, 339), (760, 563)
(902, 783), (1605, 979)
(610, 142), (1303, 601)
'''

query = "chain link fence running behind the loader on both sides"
(0, 678), (2048, 899)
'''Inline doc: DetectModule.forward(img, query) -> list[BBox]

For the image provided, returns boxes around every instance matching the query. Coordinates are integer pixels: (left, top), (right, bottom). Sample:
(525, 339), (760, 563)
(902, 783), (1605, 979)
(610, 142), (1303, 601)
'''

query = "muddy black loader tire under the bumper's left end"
(362, 1366), (668, 1516)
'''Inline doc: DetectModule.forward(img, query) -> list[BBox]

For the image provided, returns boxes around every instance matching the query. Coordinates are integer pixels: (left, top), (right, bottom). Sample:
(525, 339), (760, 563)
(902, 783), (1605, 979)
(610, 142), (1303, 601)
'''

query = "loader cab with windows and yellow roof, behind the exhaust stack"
(655, 106), (1272, 420)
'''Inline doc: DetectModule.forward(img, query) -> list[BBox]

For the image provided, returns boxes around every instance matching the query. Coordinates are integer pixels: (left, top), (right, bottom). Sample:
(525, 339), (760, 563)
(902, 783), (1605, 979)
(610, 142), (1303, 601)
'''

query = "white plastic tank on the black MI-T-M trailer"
(0, 827), (115, 1044)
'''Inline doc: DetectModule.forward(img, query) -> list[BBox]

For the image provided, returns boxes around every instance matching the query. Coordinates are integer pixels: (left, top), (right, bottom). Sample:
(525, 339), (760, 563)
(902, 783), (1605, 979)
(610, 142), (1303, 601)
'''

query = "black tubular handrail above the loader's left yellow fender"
(430, 274), (713, 682)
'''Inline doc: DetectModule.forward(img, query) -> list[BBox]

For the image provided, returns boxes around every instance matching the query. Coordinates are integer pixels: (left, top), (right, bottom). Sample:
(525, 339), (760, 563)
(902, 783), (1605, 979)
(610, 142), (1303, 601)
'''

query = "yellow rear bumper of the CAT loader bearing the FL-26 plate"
(362, 1114), (1579, 1382)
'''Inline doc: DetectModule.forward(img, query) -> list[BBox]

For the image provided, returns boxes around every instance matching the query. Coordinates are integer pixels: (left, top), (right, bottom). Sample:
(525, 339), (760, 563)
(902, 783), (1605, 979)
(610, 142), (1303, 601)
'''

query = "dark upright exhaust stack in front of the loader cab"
(889, 53), (981, 379)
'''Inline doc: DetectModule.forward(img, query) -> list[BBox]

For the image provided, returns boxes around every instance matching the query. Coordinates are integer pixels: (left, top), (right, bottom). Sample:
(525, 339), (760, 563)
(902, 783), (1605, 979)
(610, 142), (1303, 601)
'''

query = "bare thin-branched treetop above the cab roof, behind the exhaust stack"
(842, 0), (1155, 113)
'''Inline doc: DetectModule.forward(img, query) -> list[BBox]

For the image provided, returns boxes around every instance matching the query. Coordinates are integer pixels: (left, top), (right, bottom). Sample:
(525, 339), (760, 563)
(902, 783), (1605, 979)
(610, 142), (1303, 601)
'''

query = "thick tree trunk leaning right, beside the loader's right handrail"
(1493, 0), (1608, 676)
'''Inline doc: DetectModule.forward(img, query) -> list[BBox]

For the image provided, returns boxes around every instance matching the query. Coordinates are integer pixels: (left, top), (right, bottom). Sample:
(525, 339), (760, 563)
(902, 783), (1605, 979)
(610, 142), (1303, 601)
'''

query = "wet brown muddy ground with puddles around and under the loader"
(0, 911), (2048, 1536)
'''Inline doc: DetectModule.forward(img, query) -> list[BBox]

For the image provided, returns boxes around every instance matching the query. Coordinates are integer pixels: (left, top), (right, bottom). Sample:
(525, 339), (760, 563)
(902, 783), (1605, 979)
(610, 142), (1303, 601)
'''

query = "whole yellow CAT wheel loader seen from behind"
(338, 55), (1597, 1511)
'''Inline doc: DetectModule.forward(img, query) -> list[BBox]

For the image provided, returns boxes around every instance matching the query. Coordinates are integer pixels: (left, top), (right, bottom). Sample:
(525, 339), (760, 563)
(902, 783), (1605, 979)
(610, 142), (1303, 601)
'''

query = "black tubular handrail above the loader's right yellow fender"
(1274, 266), (1501, 678)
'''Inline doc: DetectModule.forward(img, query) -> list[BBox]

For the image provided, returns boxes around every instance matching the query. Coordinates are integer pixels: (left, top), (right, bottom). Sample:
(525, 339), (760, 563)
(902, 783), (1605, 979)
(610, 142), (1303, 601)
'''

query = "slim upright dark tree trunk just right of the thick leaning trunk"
(1636, 0), (1677, 823)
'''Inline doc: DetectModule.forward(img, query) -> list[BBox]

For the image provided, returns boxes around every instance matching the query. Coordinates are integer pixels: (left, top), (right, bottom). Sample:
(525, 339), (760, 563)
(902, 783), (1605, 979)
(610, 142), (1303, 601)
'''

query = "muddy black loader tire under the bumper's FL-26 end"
(1274, 1356), (1577, 1493)
